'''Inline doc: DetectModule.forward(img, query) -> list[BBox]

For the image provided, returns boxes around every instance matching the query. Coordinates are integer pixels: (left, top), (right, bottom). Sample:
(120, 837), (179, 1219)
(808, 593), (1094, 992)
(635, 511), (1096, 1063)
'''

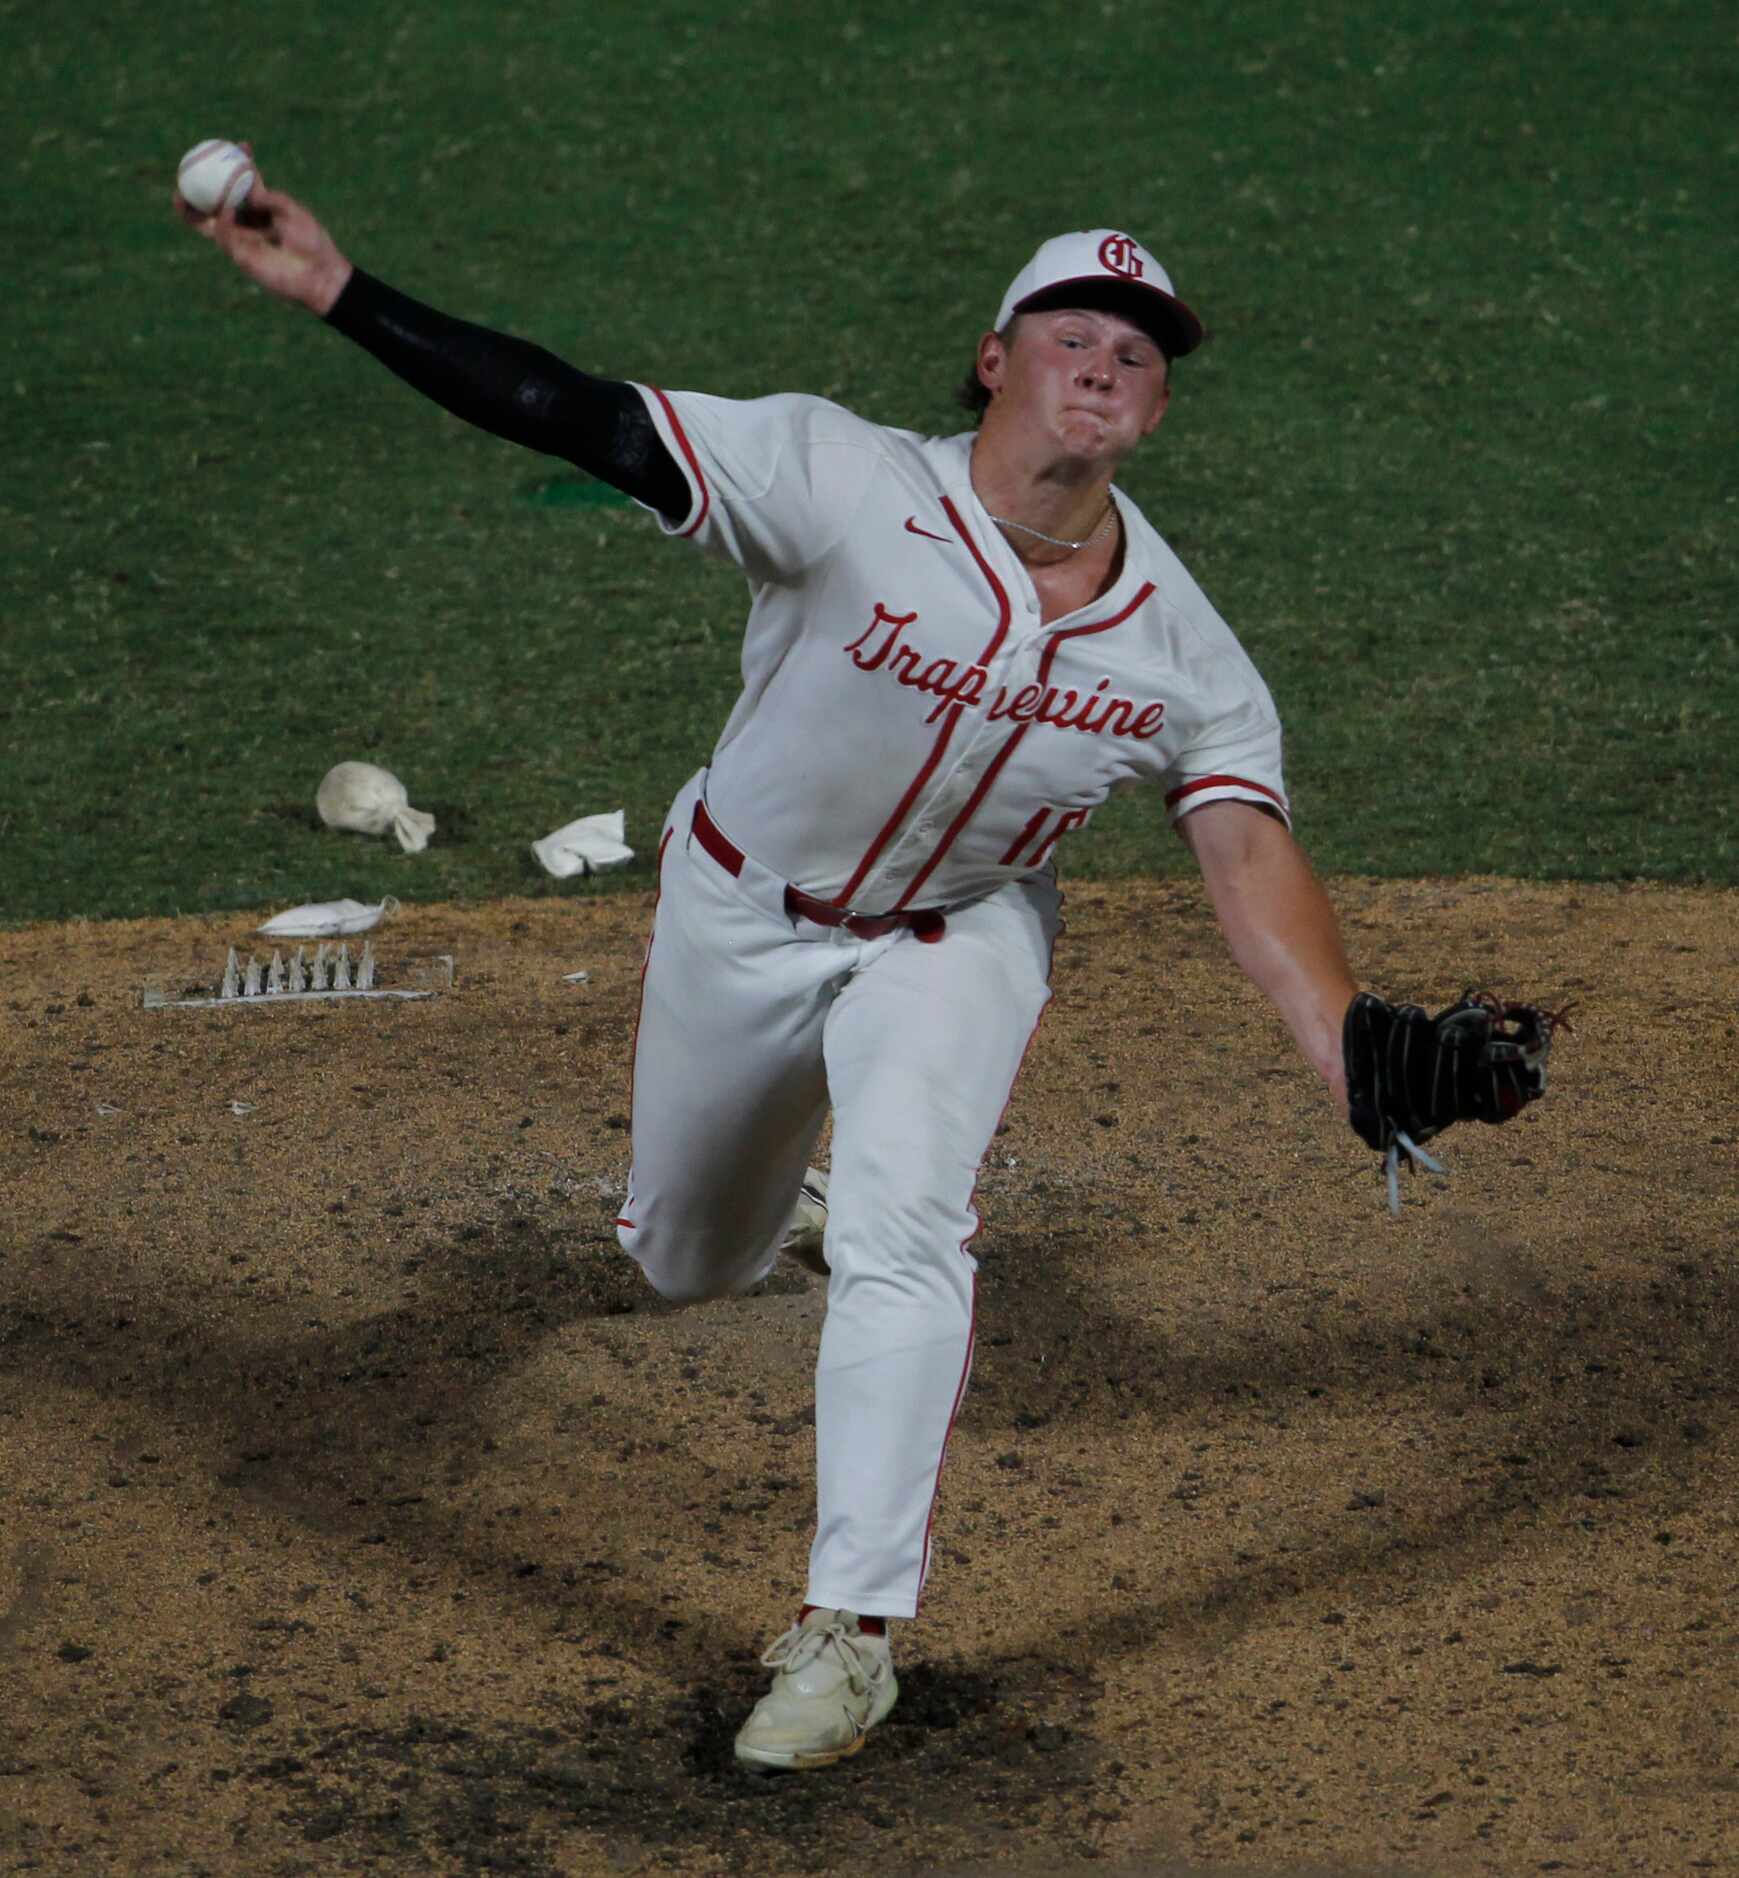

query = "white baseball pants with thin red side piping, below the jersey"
(618, 770), (1059, 1617)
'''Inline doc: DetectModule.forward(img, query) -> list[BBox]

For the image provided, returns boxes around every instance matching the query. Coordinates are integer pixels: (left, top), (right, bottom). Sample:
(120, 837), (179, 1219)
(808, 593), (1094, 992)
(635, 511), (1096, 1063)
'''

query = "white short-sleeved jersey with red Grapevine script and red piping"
(637, 385), (1288, 913)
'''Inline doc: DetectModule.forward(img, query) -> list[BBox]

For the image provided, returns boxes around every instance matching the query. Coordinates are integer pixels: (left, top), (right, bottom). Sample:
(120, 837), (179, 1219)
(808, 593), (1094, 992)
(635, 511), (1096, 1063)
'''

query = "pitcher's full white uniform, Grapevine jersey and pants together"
(616, 387), (1286, 1617)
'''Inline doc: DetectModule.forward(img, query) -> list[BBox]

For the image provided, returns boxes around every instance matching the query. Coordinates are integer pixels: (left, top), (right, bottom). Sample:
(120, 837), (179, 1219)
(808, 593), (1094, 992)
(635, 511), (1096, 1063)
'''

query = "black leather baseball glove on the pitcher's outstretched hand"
(1341, 992), (1568, 1213)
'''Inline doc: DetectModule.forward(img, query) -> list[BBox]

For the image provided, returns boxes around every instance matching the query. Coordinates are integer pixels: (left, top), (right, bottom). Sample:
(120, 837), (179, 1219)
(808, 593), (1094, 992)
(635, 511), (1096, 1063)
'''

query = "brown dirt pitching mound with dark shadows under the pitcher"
(0, 881), (1739, 1878)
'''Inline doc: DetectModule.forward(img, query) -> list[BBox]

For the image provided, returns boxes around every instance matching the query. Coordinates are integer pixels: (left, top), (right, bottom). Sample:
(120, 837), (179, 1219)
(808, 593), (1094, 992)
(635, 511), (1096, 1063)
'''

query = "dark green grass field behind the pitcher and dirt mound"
(0, 0), (1739, 922)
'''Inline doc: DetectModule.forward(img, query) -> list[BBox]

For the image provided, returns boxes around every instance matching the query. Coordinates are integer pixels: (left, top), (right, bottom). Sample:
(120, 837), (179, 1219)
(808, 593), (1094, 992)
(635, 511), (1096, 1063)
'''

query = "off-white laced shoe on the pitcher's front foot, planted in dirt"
(736, 1609), (900, 1773)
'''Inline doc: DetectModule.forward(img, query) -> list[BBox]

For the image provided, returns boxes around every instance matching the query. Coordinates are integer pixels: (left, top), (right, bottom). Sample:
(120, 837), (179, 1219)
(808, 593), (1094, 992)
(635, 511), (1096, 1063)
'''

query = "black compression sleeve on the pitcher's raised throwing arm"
(327, 269), (693, 522)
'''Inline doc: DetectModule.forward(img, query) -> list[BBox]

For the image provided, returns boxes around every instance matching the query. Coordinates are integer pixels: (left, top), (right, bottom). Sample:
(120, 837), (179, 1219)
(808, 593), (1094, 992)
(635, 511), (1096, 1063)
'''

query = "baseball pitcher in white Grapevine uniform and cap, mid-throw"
(178, 169), (1551, 1769)
